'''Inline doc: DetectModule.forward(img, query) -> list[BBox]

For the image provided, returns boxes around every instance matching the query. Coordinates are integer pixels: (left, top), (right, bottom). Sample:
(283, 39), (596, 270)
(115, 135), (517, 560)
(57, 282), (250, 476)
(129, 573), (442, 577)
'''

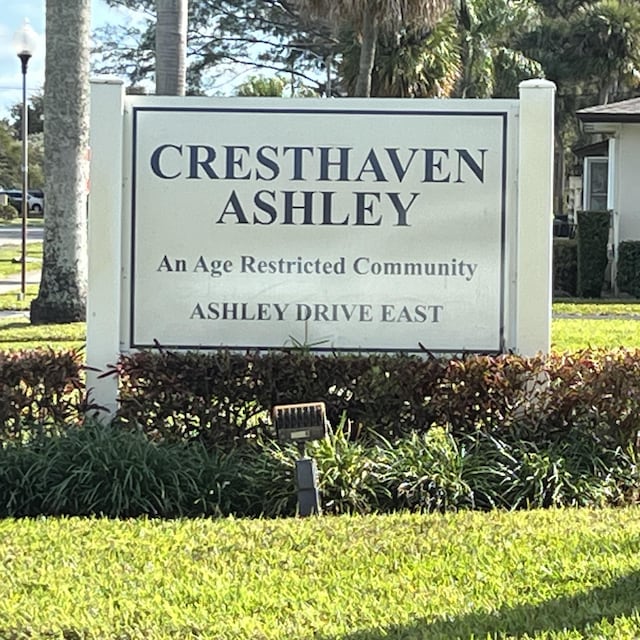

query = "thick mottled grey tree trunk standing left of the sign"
(31, 0), (91, 324)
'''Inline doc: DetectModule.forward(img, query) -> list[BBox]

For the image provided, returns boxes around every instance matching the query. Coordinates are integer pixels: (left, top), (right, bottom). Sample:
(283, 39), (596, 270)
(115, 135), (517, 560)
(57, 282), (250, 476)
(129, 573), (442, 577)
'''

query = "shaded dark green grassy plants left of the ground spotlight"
(0, 422), (244, 517)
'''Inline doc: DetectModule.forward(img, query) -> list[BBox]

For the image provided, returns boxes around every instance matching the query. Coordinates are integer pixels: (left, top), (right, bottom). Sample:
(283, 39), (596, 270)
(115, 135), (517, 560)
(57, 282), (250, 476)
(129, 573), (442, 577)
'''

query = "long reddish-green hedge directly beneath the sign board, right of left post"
(107, 350), (640, 447)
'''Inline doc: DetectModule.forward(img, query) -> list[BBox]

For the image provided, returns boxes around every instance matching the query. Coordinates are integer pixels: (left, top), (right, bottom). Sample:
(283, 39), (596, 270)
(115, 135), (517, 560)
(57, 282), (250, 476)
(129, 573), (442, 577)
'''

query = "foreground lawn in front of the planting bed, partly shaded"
(0, 509), (640, 640)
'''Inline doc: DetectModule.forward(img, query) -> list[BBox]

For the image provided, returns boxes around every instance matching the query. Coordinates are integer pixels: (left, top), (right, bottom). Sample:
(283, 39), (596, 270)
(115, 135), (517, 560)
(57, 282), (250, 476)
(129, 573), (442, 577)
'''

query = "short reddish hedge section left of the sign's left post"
(0, 349), (89, 443)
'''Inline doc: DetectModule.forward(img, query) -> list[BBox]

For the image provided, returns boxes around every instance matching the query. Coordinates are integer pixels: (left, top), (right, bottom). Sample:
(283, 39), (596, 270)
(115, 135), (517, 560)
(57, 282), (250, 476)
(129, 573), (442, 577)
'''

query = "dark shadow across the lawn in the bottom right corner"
(325, 572), (640, 640)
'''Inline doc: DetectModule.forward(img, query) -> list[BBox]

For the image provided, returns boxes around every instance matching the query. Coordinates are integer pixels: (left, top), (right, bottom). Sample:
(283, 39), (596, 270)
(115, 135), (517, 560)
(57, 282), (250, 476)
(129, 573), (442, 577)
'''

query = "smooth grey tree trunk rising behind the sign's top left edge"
(156, 0), (188, 96)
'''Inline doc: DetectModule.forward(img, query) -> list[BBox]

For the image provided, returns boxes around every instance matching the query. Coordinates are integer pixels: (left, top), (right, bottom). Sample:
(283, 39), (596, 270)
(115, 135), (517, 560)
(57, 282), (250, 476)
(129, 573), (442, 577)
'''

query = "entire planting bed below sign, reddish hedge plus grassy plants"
(0, 350), (640, 517)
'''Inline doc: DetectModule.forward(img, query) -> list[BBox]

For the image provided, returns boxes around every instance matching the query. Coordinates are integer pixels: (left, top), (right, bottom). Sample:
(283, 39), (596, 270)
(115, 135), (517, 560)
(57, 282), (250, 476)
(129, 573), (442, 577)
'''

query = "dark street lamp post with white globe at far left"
(13, 18), (38, 300)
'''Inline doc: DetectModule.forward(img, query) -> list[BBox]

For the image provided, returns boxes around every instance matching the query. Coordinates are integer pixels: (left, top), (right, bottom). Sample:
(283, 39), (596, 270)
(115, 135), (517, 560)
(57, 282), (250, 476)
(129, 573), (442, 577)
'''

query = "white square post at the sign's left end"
(86, 78), (124, 419)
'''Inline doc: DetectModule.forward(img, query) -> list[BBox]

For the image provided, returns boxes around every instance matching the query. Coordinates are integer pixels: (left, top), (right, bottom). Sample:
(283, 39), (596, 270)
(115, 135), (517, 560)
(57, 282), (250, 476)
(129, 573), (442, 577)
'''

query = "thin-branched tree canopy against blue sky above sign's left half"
(94, 0), (336, 94)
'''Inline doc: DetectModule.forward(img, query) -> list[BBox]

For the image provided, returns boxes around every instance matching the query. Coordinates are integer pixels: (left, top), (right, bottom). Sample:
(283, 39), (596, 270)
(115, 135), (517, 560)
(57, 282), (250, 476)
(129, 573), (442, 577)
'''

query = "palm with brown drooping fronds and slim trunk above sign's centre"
(295, 0), (456, 97)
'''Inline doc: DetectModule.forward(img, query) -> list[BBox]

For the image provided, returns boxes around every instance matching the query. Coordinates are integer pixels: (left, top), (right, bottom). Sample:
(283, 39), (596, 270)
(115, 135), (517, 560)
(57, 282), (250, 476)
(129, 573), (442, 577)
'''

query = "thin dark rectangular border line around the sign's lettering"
(129, 106), (509, 354)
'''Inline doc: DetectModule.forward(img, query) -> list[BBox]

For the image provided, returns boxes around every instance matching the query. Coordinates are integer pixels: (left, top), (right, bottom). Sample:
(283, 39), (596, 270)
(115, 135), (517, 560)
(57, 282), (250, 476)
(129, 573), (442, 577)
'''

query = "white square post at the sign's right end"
(515, 80), (556, 356)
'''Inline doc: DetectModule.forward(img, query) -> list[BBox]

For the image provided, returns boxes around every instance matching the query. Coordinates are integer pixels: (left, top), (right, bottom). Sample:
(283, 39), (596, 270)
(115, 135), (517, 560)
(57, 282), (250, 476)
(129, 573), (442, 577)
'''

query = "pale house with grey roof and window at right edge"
(577, 98), (640, 287)
